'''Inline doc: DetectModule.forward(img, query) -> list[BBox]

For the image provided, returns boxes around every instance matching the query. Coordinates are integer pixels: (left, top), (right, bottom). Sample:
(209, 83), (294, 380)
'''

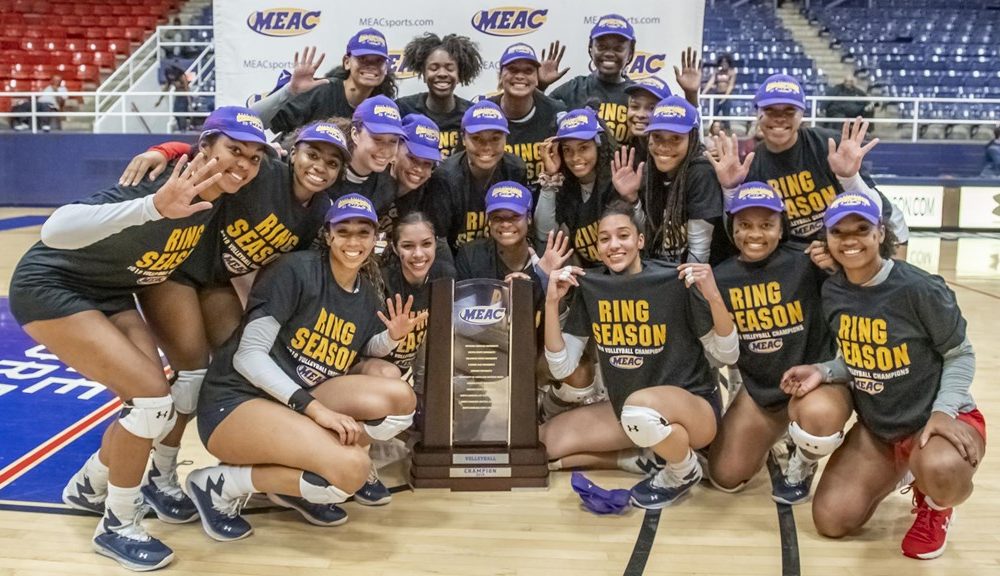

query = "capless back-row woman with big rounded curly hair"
(396, 32), (483, 158)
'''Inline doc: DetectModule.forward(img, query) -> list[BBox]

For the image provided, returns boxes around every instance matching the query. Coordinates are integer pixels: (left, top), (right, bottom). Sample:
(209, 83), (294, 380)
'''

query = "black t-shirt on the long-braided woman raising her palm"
(640, 157), (733, 264)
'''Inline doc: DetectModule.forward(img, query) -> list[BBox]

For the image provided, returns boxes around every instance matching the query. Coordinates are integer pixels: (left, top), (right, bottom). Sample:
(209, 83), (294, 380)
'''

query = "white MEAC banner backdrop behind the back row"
(214, 0), (705, 106)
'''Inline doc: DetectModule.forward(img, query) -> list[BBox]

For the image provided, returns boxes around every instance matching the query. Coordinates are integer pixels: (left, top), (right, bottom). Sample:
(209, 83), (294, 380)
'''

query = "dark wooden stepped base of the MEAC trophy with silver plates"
(410, 443), (549, 492)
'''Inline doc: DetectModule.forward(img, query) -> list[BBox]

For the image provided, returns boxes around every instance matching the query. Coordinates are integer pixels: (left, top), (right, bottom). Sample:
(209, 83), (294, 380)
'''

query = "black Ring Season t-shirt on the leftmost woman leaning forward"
(18, 162), (219, 299)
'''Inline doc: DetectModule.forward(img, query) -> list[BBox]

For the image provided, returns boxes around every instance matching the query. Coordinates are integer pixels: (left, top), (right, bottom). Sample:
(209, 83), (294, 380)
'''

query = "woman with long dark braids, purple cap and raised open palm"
(614, 96), (732, 264)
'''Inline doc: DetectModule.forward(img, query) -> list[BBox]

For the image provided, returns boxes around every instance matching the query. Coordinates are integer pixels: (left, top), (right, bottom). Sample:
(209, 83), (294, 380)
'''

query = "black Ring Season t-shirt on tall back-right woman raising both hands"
(746, 127), (880, 242)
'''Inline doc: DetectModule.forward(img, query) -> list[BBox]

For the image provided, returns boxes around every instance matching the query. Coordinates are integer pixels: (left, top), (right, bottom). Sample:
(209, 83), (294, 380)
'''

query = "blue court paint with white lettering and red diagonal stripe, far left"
(0, 300), (119, 512)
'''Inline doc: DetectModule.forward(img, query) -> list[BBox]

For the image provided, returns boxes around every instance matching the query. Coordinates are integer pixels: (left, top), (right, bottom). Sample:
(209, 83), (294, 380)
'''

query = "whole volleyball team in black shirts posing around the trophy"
(10, 14), (985, 570)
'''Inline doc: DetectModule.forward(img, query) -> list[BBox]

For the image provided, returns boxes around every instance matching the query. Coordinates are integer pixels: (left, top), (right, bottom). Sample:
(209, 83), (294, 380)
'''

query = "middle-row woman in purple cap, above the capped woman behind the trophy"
(425, 100), (527, 252)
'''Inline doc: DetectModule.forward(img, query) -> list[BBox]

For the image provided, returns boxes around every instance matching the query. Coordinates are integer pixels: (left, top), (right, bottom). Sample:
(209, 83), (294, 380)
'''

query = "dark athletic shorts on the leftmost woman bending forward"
(9, 266), (136, 326)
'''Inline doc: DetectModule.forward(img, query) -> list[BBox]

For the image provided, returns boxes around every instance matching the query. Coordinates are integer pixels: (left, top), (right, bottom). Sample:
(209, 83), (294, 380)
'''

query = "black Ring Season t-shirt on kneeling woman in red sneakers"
(823, 260), (966, 442)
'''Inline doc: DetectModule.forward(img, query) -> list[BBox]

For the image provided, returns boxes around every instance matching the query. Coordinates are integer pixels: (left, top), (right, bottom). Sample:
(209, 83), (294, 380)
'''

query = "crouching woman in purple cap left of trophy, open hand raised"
(187, 194), (426, 541)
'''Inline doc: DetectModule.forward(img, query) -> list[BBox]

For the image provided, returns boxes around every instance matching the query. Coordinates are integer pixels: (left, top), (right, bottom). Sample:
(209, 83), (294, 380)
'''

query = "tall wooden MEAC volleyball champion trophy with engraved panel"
(410, 278), (549, 490)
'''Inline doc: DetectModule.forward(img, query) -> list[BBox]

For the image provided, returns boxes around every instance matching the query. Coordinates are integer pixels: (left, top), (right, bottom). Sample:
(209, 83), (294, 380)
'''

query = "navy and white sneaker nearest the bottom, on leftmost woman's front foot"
(93, 506), (174, 572)
